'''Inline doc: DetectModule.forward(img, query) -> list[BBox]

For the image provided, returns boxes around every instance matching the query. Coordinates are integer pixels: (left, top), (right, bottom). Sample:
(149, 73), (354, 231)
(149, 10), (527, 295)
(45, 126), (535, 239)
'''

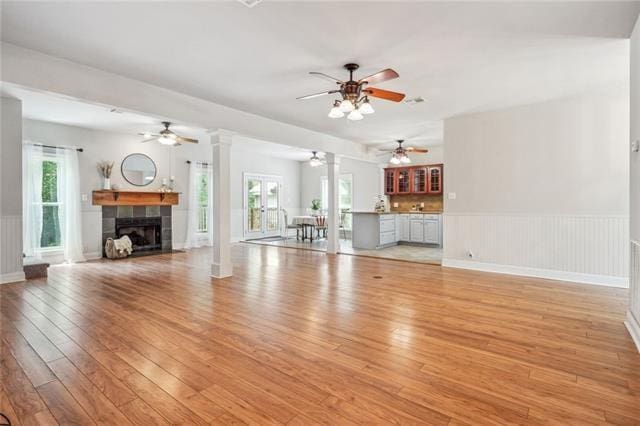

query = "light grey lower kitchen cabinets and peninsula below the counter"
(352, 211), (442, 250)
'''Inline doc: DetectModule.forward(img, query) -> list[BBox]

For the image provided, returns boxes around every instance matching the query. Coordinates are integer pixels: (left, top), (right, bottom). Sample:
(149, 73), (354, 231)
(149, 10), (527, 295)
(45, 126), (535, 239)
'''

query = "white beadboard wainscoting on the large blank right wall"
(443, 213), (629, 287)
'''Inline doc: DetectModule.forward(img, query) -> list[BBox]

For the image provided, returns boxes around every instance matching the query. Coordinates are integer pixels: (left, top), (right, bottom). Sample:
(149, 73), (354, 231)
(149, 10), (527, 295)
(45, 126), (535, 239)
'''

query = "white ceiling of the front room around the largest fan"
(1, 0), (640, 148)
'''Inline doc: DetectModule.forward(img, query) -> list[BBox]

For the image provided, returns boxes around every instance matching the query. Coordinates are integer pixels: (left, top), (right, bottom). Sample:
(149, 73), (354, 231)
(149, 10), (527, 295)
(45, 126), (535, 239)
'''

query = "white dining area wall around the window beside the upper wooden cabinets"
(300, 158), (382, 211)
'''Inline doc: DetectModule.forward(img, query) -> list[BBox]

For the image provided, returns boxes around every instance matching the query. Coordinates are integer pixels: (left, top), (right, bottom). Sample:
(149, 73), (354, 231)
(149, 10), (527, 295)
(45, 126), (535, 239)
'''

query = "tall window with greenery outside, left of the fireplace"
(39, 159), (62, 249)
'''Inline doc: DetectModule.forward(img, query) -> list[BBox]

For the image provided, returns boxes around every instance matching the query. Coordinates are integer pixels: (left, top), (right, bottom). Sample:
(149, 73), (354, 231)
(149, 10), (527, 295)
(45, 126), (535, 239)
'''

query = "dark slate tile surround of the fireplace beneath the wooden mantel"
(102, 206), (173, 257)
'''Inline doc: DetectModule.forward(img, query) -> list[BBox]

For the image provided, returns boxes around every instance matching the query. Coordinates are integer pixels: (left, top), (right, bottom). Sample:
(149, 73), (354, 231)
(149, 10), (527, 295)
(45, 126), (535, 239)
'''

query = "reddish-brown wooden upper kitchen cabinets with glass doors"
(384, 164), (443, 195)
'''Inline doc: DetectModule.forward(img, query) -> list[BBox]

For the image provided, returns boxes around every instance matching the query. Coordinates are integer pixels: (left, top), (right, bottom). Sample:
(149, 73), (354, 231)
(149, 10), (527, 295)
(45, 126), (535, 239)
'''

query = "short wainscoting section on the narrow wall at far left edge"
(0, 216), (24, 284)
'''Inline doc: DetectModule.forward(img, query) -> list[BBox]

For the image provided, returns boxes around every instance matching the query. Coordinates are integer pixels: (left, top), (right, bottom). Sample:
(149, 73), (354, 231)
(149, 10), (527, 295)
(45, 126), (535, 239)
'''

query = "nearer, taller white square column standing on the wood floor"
(211, 129), (233, 278)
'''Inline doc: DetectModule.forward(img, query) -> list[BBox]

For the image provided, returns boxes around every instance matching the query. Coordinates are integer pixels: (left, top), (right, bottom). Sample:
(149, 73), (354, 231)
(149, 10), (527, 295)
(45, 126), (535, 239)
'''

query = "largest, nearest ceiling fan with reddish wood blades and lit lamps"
(297, 64), (405, 120)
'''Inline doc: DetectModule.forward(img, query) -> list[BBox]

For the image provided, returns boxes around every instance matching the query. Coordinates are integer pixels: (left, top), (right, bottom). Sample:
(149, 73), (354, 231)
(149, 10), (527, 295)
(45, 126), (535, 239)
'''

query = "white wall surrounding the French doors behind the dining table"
(231, 141), (301, 241)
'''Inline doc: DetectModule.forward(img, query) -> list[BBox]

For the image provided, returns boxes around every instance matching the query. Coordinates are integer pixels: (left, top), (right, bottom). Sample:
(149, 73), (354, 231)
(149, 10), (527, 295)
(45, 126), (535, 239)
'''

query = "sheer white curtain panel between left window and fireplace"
(56, 148), (85, 263)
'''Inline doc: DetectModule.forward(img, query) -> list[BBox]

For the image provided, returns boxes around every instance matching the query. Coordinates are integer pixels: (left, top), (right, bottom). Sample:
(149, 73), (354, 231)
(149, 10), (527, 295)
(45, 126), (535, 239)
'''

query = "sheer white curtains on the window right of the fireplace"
(184, 161), (213, 249)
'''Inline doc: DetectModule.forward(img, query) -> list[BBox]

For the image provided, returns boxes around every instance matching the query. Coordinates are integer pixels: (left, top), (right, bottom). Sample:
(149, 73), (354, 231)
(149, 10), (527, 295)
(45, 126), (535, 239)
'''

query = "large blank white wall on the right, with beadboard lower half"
(444, 90), (629, 285)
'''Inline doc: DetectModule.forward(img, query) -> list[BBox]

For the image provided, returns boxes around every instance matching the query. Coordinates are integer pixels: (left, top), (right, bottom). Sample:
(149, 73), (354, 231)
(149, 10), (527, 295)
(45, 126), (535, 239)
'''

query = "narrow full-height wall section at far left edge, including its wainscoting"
(0, 97), (24, 284)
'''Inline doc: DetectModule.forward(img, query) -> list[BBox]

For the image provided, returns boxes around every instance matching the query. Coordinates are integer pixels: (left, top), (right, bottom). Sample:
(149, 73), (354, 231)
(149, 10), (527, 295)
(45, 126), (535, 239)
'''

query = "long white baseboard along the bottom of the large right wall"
(442, 259), (629, 288)
